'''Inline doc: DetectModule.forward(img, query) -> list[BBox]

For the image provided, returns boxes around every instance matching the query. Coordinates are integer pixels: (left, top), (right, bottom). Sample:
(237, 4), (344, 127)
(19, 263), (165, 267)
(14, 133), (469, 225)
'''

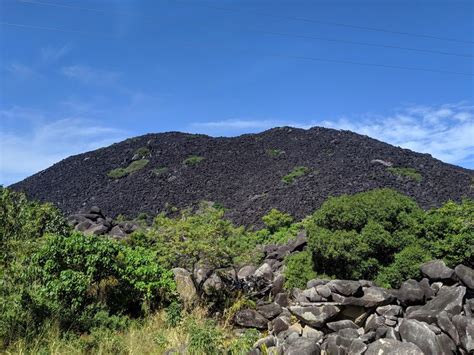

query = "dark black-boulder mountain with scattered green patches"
(11, 127), (474, 225)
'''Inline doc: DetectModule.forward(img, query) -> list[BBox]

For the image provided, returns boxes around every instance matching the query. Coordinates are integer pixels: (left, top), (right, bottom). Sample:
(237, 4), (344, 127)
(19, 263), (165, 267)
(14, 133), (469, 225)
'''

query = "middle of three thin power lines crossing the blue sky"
(18, 0), (474, 58)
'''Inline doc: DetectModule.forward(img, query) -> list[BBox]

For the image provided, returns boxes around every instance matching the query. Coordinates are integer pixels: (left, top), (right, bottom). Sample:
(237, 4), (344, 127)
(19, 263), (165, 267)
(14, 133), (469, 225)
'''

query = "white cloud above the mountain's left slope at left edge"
(0, 110), (127, 185)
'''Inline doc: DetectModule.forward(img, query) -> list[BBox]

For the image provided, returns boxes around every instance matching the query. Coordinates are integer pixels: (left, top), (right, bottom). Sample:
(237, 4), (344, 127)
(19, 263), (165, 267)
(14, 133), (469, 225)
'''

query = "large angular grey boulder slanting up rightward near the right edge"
(406, 286), (466, 323)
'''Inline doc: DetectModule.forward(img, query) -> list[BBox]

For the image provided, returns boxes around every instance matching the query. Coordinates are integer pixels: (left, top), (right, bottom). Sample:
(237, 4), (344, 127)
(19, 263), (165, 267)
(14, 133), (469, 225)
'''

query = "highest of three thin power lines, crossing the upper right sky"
(174, 0), (474, 44)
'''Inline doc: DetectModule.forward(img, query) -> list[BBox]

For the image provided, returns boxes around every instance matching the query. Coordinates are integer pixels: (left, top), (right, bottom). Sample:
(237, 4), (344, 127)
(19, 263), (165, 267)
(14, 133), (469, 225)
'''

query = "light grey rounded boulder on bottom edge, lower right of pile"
(400, 319), (442, 355)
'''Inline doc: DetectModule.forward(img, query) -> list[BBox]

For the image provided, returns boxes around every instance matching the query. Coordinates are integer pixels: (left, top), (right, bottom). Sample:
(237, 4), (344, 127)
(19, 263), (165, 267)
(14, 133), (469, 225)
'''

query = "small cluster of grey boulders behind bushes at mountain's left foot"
(68, 206), (139, 238)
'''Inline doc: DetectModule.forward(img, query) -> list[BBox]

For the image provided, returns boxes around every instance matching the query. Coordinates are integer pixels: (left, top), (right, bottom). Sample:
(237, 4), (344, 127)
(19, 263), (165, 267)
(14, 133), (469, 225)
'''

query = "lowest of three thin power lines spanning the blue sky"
(0, 21), (474, 76)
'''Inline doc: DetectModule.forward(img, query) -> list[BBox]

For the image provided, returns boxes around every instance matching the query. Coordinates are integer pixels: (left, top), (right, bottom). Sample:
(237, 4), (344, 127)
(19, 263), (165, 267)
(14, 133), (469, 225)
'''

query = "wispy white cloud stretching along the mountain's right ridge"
(190, 103), (474, 167)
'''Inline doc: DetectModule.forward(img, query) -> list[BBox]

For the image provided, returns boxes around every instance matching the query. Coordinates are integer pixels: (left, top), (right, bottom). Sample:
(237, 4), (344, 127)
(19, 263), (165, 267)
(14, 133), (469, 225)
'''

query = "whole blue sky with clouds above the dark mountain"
(0, 0), (474, 186)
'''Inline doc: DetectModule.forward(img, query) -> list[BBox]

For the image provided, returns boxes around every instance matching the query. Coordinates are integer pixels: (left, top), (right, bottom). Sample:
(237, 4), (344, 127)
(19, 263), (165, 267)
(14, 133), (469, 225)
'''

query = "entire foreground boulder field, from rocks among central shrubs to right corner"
(173, 232), (474, 355)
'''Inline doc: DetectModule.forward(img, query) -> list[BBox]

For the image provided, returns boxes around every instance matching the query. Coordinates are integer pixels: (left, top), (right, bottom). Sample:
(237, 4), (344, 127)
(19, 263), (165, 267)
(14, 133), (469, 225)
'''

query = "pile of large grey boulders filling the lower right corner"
(234, 259), (474, 355)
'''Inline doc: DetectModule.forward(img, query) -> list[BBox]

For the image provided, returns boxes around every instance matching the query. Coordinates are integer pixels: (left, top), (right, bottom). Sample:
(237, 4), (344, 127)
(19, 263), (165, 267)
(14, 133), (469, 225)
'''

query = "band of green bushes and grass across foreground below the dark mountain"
(0, 188), (474, 354)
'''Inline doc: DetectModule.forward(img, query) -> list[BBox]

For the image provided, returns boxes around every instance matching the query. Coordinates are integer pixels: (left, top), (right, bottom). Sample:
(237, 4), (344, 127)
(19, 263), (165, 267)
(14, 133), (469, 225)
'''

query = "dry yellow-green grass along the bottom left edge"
(6, 308), (260, 355)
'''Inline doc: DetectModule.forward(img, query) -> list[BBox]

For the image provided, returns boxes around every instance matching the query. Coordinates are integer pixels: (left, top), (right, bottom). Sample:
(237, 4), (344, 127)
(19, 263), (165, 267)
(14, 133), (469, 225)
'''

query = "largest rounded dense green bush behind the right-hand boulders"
(307, 189), (423, 279)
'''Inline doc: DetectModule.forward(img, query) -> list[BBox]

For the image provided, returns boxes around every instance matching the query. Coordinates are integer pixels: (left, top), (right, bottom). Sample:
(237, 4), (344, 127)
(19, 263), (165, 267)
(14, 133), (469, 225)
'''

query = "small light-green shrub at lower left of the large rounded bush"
(285, 249), (316, 289)
